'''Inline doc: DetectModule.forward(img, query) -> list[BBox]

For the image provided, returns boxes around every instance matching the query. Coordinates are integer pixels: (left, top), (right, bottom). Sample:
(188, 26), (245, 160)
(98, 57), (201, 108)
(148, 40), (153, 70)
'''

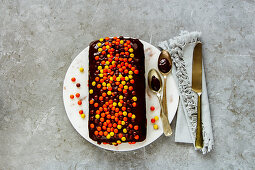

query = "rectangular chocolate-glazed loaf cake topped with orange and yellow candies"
(88, 36), (147, 145)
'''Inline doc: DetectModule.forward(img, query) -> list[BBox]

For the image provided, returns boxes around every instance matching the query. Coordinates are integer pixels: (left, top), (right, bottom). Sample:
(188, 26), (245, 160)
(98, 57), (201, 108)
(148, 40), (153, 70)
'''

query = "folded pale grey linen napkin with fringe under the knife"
(159, 31), (214, 154)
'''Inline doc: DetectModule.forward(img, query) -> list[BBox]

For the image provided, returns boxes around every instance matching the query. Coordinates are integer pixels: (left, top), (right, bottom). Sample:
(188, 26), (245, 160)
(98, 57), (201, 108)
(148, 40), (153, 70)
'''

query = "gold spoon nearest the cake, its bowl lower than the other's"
(148, 69), (172, 136)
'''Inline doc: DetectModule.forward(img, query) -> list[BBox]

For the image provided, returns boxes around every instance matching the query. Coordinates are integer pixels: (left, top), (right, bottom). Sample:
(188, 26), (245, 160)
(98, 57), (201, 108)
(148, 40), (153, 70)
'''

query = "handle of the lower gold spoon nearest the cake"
(157, 93), (173, 136)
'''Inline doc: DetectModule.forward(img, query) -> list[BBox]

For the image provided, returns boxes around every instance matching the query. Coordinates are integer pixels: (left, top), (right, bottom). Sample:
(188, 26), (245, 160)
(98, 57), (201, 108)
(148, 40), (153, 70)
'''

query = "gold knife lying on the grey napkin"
(192, 42), (203, 149)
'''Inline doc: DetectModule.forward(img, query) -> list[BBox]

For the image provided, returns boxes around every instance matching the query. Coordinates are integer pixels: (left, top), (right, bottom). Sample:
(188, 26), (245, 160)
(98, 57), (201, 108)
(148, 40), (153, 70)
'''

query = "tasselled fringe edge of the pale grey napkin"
(159, 31), (213, 154)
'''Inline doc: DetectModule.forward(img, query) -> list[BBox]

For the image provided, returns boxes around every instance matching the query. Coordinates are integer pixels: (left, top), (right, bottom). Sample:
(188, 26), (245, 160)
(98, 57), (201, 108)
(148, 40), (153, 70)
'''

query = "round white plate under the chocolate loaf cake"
(63, 40), (179, 151)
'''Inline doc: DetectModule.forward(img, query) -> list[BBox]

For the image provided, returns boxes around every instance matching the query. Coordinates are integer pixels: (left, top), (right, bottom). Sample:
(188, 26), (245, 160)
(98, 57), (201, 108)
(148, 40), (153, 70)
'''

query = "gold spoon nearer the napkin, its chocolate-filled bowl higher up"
(158, 50), (172, 134)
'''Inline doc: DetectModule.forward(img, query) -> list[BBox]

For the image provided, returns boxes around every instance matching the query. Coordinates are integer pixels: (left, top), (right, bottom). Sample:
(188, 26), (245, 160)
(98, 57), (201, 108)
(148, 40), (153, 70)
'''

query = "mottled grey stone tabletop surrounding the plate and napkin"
(0, 0), (255, 169)
